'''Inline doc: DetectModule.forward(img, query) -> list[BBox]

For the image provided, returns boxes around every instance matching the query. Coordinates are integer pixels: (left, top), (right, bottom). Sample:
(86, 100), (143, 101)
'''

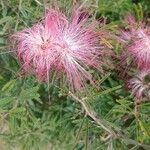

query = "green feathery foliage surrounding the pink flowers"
(0, 0), (150, 150)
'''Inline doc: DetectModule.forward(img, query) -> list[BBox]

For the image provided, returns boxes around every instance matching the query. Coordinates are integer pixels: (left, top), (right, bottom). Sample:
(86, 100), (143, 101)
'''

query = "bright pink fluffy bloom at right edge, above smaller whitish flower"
(119, 15), (150, 70)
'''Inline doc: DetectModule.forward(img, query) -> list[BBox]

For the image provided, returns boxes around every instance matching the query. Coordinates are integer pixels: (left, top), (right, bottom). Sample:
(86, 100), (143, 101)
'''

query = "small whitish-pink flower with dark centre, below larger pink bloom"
(128, 71), (150, 100)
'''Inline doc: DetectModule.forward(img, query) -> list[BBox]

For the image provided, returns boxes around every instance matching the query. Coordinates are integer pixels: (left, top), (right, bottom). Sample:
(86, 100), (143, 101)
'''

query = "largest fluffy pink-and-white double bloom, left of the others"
(13, 9), (102, 91)
